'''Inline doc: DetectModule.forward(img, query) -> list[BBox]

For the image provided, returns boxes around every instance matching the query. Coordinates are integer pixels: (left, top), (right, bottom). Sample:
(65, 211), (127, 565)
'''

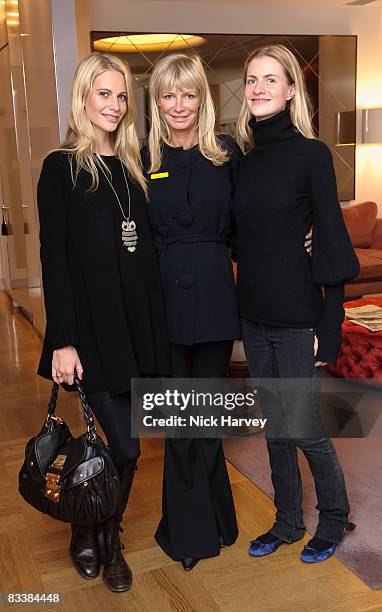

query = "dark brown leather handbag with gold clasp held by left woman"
(19, 376), (120, 527)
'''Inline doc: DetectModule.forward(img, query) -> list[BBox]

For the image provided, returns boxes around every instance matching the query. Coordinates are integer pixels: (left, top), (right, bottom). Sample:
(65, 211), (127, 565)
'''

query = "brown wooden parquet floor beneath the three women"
(0, 292), (382, 612)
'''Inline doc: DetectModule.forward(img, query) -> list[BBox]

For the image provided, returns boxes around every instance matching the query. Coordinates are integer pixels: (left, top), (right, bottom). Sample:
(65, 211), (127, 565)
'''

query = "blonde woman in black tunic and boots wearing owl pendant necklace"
(38, 53), (169, 592)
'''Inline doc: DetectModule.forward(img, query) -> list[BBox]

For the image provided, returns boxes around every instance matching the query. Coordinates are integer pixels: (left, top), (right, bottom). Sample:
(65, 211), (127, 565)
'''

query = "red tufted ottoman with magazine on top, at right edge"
(327, 297), (382, 386)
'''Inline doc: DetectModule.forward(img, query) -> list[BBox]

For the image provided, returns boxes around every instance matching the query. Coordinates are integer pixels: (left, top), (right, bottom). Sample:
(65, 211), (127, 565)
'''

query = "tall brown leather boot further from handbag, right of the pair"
(98, 461), (136, 593)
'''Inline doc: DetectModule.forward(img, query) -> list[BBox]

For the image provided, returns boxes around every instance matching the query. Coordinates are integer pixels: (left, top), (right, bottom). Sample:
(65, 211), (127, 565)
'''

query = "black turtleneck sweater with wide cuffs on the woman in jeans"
(233, 109), (359, 362)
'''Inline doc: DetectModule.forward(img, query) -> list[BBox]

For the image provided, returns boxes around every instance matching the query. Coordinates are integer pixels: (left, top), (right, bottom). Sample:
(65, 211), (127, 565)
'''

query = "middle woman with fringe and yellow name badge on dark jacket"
(143, 54), (241, 570)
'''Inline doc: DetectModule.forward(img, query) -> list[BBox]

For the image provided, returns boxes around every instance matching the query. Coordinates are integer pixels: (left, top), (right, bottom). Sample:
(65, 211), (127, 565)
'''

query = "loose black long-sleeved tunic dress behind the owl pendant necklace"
(38, 152), (170, 395)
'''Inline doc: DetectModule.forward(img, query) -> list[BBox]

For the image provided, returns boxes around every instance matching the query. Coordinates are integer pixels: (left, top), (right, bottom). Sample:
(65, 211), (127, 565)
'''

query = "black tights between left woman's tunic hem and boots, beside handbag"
(88, 391), (141, 468)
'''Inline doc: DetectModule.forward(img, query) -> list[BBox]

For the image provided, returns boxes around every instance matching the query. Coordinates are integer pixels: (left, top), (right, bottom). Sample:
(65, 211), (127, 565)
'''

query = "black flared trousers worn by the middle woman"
(155, 340), (238, 561)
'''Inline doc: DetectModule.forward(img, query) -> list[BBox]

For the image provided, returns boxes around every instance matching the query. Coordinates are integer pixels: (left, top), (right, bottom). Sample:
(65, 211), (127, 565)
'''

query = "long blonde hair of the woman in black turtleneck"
(236, 45), (315, 151)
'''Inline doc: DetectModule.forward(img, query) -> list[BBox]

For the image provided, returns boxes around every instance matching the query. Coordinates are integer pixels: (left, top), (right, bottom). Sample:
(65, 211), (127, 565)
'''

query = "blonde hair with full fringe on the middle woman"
(148, 53), (229, 172)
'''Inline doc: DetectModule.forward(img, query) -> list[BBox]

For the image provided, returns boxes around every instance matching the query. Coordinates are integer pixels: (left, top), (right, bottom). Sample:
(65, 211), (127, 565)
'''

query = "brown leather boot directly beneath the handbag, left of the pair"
(69, 525), (101, 580)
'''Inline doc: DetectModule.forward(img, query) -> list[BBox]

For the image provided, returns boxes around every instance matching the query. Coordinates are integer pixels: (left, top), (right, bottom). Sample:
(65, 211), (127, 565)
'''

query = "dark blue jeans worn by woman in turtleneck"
(242, 319), (353, 543)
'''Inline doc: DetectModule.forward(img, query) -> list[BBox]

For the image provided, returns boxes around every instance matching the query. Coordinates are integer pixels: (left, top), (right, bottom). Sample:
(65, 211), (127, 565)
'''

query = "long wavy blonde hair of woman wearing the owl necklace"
(59, 52), (147, 195)
